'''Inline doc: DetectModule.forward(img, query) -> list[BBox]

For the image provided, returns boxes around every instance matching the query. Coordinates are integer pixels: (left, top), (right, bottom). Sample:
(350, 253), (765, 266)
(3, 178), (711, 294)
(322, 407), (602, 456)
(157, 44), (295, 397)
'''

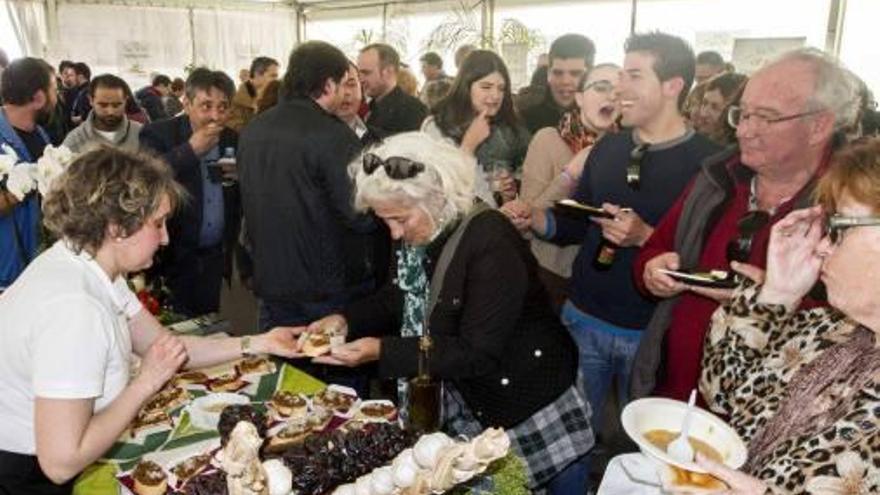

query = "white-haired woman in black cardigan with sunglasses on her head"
(309, 133), (593, 493)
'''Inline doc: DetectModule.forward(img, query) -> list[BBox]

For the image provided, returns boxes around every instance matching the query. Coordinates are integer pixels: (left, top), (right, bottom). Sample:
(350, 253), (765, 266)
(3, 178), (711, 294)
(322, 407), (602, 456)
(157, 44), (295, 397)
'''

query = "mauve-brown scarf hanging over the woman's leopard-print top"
(745, 326), (880, 473)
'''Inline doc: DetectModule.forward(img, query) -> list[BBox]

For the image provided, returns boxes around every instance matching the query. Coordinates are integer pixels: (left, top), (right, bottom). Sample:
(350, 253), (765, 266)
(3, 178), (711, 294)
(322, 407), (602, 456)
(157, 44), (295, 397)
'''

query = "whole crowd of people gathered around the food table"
(0, 24), (880, 495)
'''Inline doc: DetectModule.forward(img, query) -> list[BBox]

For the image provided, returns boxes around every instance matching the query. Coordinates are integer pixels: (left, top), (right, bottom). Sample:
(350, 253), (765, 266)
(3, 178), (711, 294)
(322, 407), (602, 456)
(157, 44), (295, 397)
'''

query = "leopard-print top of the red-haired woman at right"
(700, 282), (880, 494)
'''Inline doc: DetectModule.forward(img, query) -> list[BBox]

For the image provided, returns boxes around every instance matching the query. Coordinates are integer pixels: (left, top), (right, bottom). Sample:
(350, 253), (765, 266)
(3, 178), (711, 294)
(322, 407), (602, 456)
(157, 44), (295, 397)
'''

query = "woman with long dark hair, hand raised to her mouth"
(422, 50), (531, 205)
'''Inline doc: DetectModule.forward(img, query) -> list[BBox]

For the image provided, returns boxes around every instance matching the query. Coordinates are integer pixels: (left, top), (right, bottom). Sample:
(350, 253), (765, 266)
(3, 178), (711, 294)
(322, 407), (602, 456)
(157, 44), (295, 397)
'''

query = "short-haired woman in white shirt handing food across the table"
(0, 147), (296, 495)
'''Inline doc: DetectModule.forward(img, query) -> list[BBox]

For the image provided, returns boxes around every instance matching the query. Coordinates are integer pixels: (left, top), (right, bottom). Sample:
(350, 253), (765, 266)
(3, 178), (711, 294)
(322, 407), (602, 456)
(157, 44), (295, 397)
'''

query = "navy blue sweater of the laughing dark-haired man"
(549, 130), (720, 329)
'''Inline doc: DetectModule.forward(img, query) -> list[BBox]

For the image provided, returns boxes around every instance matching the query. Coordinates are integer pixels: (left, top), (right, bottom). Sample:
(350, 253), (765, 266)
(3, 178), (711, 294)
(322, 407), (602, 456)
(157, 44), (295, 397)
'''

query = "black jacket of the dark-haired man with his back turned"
(238, 98), (376, 304)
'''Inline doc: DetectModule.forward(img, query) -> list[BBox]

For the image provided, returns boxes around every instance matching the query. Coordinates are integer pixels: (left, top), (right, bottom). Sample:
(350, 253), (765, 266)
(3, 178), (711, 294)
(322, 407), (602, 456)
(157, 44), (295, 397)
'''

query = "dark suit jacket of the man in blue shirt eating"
(140, 115), (241, 312)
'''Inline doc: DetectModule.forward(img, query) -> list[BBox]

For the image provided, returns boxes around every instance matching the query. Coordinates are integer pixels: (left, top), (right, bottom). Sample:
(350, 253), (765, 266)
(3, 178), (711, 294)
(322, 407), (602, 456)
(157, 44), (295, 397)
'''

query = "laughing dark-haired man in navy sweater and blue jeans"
(506, 33), (719, 476)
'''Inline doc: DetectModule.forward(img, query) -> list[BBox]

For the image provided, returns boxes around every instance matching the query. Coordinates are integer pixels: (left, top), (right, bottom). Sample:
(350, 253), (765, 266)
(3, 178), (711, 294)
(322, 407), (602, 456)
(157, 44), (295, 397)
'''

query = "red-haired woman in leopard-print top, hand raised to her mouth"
(700, 138), (880, 494)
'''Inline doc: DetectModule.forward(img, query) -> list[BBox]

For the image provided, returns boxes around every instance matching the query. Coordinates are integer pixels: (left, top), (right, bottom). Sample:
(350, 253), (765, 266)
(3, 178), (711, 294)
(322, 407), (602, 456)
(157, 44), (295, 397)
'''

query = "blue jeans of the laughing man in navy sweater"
(561, 301), (642, 433)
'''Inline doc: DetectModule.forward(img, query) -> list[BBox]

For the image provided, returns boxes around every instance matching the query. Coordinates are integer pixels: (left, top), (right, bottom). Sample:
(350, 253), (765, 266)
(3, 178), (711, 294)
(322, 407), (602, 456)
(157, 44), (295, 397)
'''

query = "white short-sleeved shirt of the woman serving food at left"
(0, 241), (143, 455)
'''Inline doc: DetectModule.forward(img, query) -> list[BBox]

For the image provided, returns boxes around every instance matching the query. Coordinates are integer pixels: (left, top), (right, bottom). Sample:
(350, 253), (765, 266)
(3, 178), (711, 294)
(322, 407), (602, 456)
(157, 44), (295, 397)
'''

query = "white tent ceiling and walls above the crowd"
(0, 0), (880, 93)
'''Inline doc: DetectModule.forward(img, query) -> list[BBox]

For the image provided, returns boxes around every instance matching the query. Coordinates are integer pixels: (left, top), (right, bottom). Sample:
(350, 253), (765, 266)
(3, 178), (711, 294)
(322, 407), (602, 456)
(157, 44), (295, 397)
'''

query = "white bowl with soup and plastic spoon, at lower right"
(620, 397), (747, 473)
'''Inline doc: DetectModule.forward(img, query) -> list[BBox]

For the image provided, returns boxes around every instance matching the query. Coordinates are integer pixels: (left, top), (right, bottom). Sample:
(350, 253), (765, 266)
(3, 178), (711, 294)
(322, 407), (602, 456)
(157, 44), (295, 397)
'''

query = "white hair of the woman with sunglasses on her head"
(349, 132), (477, 225)
